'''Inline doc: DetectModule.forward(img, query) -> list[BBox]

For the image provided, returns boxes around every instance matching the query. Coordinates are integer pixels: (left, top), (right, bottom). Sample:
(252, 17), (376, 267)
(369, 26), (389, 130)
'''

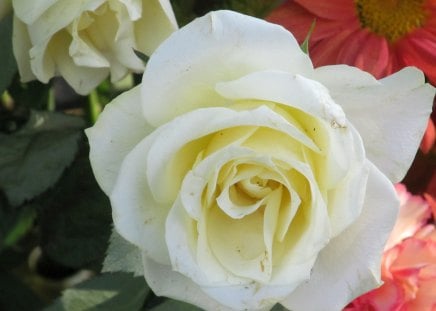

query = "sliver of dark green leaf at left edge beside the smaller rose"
(0, 14), (17, 94)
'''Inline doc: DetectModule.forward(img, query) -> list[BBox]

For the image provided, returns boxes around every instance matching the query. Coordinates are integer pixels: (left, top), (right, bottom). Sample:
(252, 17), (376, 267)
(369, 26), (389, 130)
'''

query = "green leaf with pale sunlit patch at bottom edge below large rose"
(45, 273), (150, 311)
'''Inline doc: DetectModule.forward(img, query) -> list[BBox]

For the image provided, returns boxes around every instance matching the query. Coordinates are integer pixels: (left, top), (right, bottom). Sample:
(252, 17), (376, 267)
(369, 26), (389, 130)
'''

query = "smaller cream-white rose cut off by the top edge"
(12, 0), (177, 94)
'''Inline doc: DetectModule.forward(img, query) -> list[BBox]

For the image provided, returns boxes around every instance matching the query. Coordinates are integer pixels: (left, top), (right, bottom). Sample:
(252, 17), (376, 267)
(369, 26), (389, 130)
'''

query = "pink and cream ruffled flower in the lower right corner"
(344, 185), (436, 311)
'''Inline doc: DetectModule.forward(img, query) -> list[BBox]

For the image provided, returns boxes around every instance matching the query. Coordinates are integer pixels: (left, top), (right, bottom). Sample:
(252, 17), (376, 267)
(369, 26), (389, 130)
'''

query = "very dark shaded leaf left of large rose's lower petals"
(38, 149), (112, 269)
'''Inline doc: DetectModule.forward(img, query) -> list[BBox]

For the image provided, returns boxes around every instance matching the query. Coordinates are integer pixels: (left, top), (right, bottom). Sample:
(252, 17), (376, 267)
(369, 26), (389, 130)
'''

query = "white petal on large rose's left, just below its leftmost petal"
(110, 130), (171, 264)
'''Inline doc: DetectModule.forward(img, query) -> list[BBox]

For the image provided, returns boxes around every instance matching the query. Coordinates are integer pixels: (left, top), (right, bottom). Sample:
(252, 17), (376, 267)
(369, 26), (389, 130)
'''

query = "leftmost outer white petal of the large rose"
(85, 87), (152, 195)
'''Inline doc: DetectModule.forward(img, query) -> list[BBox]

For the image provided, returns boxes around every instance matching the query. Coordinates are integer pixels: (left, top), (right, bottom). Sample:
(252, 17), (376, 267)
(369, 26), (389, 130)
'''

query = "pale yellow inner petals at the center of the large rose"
(171, 103), (329, 282)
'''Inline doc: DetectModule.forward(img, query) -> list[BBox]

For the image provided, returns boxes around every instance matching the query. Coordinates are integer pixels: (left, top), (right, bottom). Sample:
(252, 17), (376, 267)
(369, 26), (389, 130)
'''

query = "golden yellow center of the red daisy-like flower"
(355, 0), (427, 42)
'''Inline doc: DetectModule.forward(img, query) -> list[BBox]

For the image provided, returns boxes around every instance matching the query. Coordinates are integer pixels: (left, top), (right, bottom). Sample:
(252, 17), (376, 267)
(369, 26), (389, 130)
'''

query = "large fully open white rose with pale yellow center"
(87, 11), (434, 310)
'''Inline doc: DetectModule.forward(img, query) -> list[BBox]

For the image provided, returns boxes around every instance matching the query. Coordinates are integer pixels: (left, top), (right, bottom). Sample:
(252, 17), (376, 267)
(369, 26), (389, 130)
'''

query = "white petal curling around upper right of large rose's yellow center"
(216, 71), (374, 236)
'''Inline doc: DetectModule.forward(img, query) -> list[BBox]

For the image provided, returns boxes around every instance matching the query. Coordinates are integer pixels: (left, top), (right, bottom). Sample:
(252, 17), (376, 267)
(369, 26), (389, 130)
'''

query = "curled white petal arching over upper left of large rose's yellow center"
(147, 106), (317, 203)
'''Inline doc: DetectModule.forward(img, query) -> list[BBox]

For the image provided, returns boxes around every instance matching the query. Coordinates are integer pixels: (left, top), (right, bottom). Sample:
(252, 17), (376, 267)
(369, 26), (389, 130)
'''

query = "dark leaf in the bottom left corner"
(0, 270), (42, 311)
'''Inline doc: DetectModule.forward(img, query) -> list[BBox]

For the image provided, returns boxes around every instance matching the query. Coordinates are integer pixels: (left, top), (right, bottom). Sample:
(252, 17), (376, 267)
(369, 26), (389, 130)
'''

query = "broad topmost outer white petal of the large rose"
(142, 11), (312, 125)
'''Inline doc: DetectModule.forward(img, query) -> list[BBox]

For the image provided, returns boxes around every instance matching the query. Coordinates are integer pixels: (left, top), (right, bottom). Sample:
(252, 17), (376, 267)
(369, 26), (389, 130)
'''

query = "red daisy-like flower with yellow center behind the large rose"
(268, 0), (436, 84)
